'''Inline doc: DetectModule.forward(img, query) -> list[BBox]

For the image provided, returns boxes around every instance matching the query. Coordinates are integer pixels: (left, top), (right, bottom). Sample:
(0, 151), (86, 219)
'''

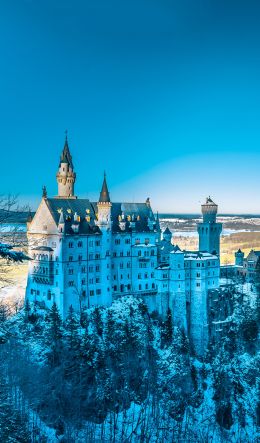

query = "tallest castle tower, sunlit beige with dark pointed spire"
(56, 134), (76, 198)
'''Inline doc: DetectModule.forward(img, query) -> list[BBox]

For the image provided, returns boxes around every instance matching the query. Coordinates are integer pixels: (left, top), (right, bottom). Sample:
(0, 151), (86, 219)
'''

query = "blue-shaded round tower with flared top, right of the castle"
(197, 197), (222, 255)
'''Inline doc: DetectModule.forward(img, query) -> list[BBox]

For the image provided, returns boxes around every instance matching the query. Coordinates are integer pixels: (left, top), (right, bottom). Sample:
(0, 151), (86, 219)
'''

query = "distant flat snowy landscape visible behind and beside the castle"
(0, 212), (260, 302)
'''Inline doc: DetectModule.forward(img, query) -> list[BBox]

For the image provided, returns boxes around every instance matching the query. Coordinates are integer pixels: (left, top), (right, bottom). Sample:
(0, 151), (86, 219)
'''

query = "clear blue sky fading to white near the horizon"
(0, 0), (260, 212)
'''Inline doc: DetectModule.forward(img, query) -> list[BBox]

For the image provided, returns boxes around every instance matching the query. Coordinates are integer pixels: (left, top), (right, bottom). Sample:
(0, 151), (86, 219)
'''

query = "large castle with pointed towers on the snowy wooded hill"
(26, 137), (222, 354)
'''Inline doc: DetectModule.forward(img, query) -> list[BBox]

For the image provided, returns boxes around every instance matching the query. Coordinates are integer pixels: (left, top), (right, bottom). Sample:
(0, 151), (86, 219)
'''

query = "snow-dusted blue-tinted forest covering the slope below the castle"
(0, 297), (260, 443)
